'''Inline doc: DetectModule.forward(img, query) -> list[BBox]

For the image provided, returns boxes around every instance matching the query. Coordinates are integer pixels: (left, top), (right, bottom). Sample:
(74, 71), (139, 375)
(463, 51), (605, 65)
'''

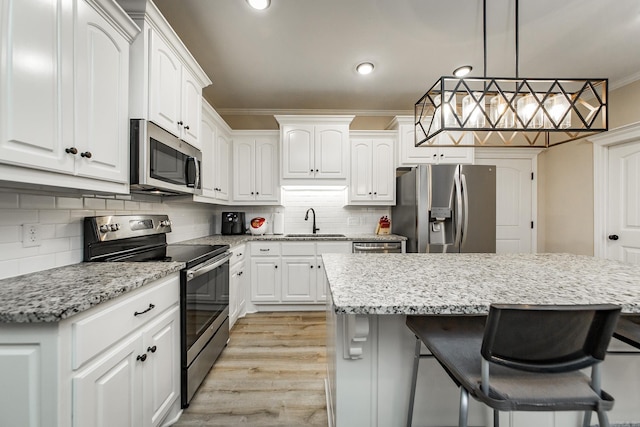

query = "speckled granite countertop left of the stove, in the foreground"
(0, 262), (185, 323)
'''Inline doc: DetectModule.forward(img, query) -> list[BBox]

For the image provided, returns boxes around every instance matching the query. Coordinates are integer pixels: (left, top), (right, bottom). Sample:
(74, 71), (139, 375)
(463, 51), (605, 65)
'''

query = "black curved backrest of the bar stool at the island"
(481, 304), (620, 372)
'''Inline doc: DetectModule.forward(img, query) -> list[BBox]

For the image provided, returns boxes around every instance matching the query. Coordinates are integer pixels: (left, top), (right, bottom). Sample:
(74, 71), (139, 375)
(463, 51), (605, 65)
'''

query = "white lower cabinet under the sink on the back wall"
(250, 241), (351, 305)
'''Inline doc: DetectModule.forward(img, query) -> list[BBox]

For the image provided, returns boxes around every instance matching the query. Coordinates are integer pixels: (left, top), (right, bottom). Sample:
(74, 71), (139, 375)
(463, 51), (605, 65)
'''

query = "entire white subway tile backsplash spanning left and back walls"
(0, 187), (389, 279)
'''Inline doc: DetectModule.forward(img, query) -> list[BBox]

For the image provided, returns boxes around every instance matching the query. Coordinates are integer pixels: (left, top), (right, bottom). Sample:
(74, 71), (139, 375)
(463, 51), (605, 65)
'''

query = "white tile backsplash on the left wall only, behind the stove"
(0, 190), (213, 279)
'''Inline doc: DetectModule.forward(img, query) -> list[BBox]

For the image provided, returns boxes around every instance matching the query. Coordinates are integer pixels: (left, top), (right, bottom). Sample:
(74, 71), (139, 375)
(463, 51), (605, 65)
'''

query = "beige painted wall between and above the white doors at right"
(538, 80), (640, 255)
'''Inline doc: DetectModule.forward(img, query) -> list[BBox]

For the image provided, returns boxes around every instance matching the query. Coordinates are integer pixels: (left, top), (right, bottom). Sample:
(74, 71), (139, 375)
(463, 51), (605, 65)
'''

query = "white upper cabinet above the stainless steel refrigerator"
(390, 116), (474, 166)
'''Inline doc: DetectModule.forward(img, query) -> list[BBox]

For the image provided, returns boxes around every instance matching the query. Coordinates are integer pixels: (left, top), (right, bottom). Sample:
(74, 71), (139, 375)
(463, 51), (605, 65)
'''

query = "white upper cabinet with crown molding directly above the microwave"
(119, 0), (211, 149)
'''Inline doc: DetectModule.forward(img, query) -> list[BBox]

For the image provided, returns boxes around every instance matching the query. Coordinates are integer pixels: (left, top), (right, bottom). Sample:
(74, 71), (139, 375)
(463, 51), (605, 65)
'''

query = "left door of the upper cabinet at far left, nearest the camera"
(0, 0), (74, 173)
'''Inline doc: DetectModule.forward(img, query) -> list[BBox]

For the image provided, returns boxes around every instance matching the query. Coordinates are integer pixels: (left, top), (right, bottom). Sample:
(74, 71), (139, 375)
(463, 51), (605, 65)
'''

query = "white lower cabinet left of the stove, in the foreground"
(0, 273), (180, 427)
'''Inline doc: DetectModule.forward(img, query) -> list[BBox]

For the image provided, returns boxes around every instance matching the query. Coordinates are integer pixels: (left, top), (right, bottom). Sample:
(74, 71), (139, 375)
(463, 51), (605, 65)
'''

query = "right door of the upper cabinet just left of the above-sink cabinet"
(255, 138), (280, 201)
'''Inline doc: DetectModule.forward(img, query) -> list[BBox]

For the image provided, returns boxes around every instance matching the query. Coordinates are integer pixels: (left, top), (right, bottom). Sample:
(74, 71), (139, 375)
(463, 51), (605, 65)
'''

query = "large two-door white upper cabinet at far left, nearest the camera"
(0, 0), (139, 193)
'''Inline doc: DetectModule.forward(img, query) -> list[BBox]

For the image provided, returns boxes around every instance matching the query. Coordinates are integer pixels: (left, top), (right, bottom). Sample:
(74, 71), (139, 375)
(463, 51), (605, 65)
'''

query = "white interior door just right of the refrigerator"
(476, 158), (534, 253)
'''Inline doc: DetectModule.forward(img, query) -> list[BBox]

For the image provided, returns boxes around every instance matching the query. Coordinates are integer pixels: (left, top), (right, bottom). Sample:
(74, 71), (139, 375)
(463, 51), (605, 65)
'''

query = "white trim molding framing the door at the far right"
(587, 122), (640, 258)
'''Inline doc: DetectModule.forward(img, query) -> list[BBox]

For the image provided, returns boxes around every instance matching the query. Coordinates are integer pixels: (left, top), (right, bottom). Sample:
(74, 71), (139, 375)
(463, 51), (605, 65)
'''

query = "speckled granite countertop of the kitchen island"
(322, 254), (640, 314)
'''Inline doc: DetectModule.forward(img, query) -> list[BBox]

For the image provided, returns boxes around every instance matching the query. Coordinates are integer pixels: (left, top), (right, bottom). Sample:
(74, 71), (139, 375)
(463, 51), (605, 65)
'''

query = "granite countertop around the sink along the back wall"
(179, 233), (407, 247)
